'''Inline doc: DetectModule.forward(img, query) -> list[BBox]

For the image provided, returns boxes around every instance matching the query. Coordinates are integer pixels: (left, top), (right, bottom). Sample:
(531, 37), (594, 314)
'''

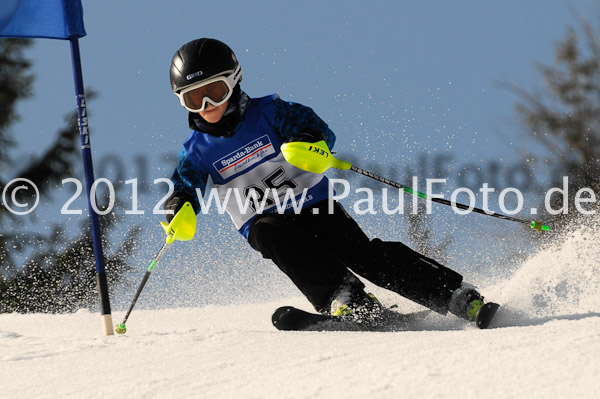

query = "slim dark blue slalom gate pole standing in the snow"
(69, 37), (113, 335)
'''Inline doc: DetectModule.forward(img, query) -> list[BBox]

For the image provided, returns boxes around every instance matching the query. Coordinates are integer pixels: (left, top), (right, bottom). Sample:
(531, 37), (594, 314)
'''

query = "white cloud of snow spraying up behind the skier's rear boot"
(485, 219), (600, 325)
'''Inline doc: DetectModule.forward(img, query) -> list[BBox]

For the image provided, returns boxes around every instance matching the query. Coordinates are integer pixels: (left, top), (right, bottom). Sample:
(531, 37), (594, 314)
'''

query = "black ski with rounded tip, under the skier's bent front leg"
(271, 306), (431, 331)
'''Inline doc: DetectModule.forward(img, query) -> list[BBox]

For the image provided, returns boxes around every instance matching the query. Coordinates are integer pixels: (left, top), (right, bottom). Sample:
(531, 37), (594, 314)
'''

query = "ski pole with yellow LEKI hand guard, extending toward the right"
(281, 140), (550, 231)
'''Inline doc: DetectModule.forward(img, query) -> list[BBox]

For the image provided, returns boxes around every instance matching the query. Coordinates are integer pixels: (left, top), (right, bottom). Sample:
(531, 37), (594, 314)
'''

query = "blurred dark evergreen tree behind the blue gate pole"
(0, 39), (140, 313)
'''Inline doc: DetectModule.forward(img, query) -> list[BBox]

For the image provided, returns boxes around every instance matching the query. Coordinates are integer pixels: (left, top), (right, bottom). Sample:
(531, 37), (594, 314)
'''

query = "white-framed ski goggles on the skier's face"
(175, 65), (241, 112)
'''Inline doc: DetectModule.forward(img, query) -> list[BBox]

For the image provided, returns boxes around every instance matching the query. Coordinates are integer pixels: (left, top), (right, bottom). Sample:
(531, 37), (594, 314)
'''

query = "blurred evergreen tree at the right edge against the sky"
(513, 18), (600, 226)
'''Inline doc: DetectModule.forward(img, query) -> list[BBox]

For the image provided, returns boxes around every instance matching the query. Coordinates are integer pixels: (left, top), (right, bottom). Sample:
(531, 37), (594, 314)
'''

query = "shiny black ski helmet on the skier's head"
(170, 38), (242, 94)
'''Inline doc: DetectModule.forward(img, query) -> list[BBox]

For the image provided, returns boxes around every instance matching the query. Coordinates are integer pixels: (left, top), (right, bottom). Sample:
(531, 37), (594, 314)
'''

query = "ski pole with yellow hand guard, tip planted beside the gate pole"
(115, 202), (196, 334)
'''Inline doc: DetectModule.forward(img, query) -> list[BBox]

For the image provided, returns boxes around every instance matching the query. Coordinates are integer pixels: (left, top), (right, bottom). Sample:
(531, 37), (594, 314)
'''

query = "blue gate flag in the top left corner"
(0, 0), (86, 39)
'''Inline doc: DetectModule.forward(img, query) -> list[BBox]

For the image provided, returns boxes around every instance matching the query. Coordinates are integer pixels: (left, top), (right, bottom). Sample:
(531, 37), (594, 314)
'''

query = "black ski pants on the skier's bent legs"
(248, 200), (462, 314)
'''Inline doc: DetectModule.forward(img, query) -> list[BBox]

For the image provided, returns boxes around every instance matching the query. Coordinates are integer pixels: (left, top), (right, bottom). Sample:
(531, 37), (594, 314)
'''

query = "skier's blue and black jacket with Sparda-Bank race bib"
(171, 95), (335, 238)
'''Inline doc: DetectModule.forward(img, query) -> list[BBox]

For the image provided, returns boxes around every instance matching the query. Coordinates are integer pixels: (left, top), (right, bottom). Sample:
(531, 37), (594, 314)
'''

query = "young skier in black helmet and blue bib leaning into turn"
(165, 38), (492, 324)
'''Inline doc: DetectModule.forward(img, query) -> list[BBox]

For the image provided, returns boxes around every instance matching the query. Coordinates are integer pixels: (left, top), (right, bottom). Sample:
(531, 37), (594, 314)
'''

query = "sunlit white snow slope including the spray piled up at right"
(0, 223), (600, 399)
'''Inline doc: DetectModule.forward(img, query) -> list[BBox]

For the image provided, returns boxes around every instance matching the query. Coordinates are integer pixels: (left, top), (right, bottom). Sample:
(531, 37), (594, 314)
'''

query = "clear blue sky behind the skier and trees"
(5, 0), (598, 306)
